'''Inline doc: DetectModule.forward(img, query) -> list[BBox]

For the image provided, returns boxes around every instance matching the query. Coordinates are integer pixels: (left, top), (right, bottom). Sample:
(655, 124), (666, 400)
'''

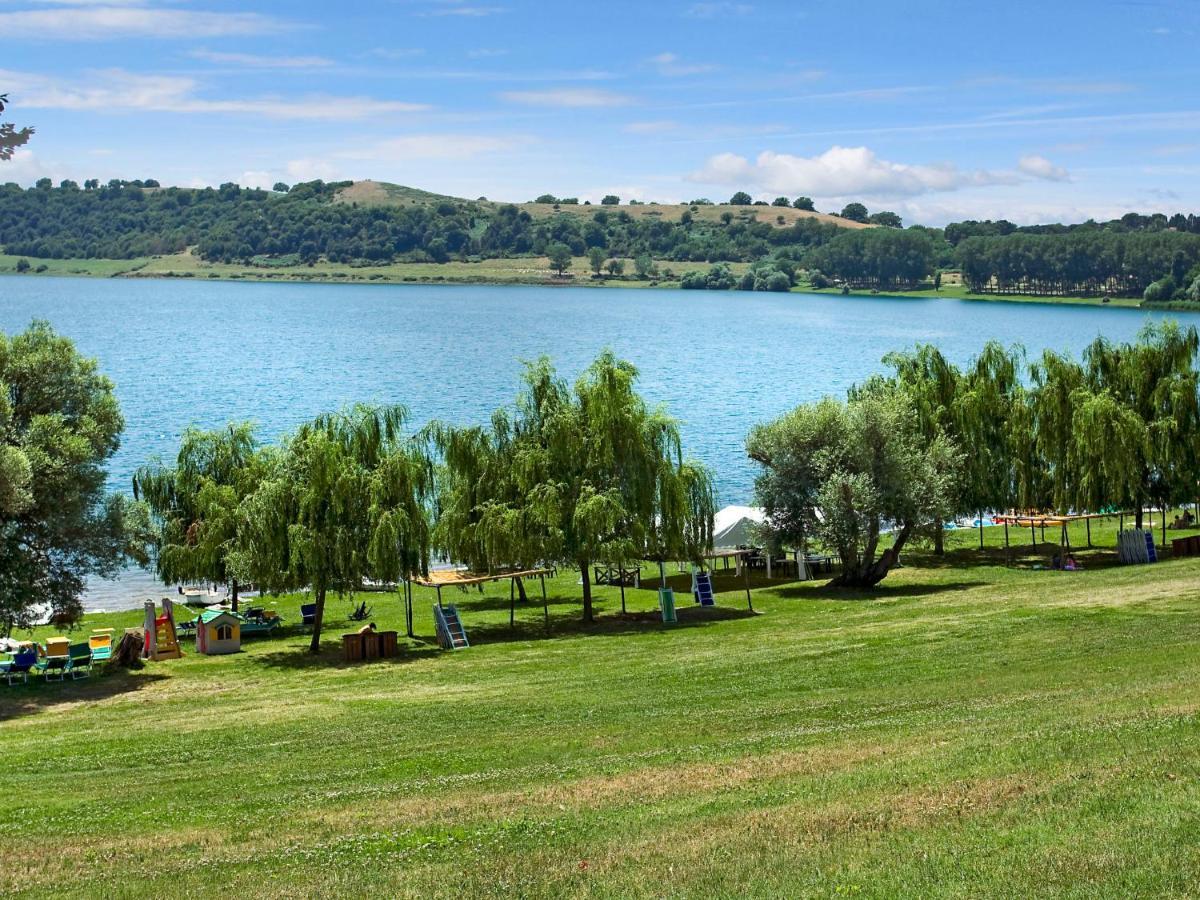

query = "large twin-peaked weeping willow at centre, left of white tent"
(434, 352), (715, 622)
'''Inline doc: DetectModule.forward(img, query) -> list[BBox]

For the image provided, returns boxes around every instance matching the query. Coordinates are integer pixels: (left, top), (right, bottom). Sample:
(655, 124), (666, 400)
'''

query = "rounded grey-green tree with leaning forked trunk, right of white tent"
(746, 382), (959, 588)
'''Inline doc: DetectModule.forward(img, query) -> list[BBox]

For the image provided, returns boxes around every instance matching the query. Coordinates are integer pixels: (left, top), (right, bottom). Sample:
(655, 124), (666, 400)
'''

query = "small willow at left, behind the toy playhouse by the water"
(133, 422), (265, 612)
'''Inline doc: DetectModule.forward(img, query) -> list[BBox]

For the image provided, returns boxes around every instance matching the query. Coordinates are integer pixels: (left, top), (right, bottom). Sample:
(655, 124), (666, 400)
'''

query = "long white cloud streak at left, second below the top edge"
(0, 68), (428, 121)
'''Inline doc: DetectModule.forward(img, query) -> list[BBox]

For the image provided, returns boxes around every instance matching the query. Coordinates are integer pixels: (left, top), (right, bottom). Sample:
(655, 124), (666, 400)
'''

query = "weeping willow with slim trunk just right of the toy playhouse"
(234, 406), (431, 653)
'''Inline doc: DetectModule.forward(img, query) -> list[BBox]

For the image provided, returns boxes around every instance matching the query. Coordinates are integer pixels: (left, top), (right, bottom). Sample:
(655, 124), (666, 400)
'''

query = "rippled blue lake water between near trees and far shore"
(0, 276), (1195, 602)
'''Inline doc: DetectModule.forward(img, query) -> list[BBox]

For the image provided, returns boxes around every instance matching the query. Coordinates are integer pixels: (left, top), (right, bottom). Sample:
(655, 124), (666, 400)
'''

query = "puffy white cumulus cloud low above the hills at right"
(689, 146), (1019, 197)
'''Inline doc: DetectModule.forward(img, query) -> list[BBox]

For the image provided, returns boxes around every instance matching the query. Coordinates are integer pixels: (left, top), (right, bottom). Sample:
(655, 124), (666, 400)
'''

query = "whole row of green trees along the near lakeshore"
(0, 323), (1200, 650)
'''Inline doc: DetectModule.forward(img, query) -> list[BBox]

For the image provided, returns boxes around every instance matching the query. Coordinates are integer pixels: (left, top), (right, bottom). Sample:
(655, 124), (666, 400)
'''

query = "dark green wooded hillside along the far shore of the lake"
(0, 179), (1200, 302)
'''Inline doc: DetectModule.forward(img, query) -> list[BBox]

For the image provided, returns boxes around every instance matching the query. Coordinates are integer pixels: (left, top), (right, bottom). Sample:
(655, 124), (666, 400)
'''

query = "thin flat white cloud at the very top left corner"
(0, 4), (292, 41)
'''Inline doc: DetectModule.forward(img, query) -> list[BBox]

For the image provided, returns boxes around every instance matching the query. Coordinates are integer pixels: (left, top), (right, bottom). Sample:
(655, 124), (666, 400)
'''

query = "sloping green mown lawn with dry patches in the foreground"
(0, 511), (1200, 898)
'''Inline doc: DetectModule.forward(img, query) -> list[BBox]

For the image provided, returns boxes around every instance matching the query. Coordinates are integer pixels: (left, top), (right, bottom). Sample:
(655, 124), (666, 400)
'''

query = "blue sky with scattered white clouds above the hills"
(0, 0), (1200, 226)
